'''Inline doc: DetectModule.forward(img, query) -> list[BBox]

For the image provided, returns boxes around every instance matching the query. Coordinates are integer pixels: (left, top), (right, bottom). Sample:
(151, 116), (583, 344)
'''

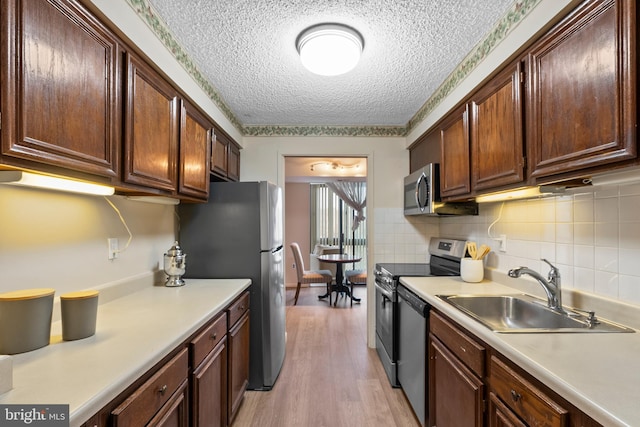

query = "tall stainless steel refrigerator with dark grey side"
(178, 181), (285, 390)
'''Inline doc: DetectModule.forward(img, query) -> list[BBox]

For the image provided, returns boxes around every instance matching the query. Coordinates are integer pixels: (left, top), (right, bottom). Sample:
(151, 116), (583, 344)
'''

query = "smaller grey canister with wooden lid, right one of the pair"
(60, 291), (98, 341)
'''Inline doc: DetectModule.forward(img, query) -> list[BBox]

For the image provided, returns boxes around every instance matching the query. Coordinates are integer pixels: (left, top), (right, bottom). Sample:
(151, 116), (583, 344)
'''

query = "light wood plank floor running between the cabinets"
(233, 286), (419, 427)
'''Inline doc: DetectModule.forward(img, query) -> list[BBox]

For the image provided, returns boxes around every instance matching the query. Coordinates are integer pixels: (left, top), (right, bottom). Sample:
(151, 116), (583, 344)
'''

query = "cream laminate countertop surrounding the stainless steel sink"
(400, 277), (640, 427)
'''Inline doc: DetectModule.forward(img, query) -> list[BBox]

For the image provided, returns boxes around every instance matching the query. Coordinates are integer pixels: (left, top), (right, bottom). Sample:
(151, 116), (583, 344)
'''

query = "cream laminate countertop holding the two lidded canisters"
(0, 279), (251, 427)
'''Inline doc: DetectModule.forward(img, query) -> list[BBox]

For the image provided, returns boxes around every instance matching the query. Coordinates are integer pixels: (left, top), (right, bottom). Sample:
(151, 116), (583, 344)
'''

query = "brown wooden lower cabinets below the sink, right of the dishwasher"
(428, 310), (601, 427)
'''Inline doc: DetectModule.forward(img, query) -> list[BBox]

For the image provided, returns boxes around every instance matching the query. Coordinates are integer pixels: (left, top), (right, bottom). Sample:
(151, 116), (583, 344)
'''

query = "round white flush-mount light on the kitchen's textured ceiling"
(296, 24), (364, 76)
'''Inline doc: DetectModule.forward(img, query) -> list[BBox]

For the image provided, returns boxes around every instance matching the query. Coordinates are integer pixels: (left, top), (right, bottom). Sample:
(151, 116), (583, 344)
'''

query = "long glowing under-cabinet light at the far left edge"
(0, 171), (115, 196)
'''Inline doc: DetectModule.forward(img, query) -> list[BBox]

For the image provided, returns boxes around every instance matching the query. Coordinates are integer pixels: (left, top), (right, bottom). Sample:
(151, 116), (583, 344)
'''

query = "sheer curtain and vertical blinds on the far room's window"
(310, 181), (367, 269)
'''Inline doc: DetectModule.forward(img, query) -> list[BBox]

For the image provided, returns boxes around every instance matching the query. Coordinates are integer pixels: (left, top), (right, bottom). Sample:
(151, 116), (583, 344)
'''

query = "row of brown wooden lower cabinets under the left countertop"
(82, 292), (249, 427)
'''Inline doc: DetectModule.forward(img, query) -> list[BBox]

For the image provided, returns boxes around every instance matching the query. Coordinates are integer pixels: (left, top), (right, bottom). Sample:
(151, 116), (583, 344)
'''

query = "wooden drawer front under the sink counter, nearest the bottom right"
(489, 356), (568, 427)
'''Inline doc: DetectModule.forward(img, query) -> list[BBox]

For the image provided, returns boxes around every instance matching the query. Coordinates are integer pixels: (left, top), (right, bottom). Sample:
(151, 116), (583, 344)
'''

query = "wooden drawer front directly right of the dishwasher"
(429, 311), (485, 378)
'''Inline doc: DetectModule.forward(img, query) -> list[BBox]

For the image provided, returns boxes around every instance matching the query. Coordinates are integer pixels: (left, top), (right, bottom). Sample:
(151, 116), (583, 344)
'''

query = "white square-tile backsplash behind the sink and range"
(374, 184), (640, 305)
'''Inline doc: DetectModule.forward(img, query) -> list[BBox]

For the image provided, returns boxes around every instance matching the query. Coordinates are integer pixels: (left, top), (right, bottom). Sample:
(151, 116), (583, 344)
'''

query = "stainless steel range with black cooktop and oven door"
(374, 237), (466, 387)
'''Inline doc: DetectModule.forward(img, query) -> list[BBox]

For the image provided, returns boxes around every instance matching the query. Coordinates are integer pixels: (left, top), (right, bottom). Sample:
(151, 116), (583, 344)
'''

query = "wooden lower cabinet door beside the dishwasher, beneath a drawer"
(428, 335), (484, 427)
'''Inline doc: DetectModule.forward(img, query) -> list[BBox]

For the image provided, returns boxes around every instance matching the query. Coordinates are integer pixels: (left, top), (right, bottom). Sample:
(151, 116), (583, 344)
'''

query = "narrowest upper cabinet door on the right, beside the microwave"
(440, 105), (471, 197)
